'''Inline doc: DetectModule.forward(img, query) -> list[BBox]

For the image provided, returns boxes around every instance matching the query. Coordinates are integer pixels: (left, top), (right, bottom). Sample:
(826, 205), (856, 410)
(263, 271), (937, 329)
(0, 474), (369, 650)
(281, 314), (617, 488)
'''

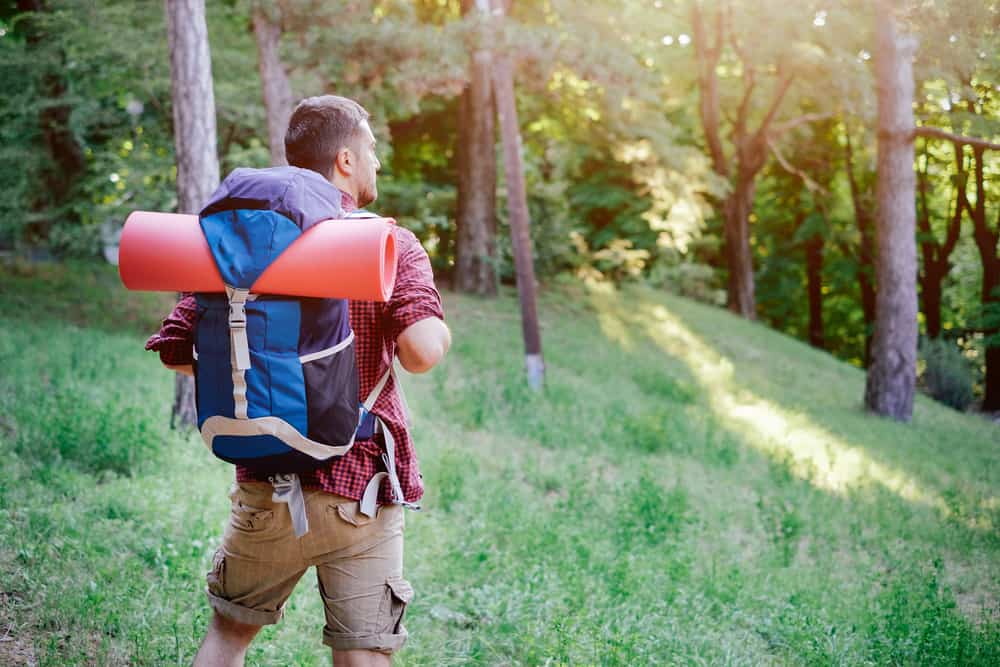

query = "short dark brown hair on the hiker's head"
(285, 95), (369, 178)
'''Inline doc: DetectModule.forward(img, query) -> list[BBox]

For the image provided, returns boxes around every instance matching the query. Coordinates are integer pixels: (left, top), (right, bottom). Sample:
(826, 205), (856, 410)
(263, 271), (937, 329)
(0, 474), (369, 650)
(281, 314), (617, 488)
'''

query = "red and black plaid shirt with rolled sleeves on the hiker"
(146, 194), (444, 503)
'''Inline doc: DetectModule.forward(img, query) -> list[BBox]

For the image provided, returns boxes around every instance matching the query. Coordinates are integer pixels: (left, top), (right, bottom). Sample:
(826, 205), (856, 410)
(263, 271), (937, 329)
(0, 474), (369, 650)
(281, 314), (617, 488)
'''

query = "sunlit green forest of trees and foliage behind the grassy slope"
(0, 0), (1000, 410)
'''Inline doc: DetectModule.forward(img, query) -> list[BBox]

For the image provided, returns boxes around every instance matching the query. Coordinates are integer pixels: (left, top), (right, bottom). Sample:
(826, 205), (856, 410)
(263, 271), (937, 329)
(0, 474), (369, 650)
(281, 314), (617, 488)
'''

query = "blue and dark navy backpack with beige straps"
(195, 167), (390, 480)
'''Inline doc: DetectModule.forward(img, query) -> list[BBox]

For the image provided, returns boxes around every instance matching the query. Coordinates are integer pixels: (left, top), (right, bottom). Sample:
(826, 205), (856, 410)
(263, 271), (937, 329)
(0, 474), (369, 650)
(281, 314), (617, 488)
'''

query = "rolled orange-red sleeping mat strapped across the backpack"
(118, 211), (396, 301)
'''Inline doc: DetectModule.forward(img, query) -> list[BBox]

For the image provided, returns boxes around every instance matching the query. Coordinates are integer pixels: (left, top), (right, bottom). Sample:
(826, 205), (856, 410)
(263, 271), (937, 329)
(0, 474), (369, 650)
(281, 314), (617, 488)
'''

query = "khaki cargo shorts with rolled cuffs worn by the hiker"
(206, 483), (413, 653)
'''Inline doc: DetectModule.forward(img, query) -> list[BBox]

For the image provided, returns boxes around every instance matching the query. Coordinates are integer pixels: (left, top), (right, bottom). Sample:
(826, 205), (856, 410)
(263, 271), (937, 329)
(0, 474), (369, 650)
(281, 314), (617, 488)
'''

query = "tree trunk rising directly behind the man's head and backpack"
(251, 3), (292, 165)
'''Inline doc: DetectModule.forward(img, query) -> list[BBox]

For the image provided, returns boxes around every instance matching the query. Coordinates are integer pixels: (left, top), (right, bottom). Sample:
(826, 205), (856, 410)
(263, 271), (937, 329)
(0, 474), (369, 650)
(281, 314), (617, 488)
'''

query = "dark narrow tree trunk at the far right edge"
(964, 146), (1000, 412)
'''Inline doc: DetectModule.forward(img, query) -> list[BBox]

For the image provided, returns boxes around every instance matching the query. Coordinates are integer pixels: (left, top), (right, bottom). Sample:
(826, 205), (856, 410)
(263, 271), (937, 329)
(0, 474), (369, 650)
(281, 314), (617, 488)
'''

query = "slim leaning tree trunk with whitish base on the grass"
(492, 0), (545, 390)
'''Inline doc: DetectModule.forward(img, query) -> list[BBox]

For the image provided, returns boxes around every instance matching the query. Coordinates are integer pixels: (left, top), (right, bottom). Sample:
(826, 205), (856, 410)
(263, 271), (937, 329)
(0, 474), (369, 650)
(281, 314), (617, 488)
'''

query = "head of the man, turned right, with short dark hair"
(285, 95), (381, 206)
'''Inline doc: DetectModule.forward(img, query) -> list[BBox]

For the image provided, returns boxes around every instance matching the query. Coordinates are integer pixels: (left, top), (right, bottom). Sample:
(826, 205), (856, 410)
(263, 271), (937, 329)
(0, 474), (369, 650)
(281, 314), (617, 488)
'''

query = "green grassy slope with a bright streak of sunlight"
(0, 264), (1000, 666)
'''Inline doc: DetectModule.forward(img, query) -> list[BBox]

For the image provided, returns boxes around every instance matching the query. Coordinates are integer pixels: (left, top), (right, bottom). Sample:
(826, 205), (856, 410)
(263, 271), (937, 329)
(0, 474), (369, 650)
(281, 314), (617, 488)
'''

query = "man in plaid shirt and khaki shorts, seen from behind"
(146, 95), (451, 667)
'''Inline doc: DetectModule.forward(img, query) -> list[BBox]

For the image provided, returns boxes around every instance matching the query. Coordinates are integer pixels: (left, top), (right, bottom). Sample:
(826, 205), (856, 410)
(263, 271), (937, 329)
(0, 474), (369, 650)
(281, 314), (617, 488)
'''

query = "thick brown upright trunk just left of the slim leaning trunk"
(455, 0), (497, 296)
